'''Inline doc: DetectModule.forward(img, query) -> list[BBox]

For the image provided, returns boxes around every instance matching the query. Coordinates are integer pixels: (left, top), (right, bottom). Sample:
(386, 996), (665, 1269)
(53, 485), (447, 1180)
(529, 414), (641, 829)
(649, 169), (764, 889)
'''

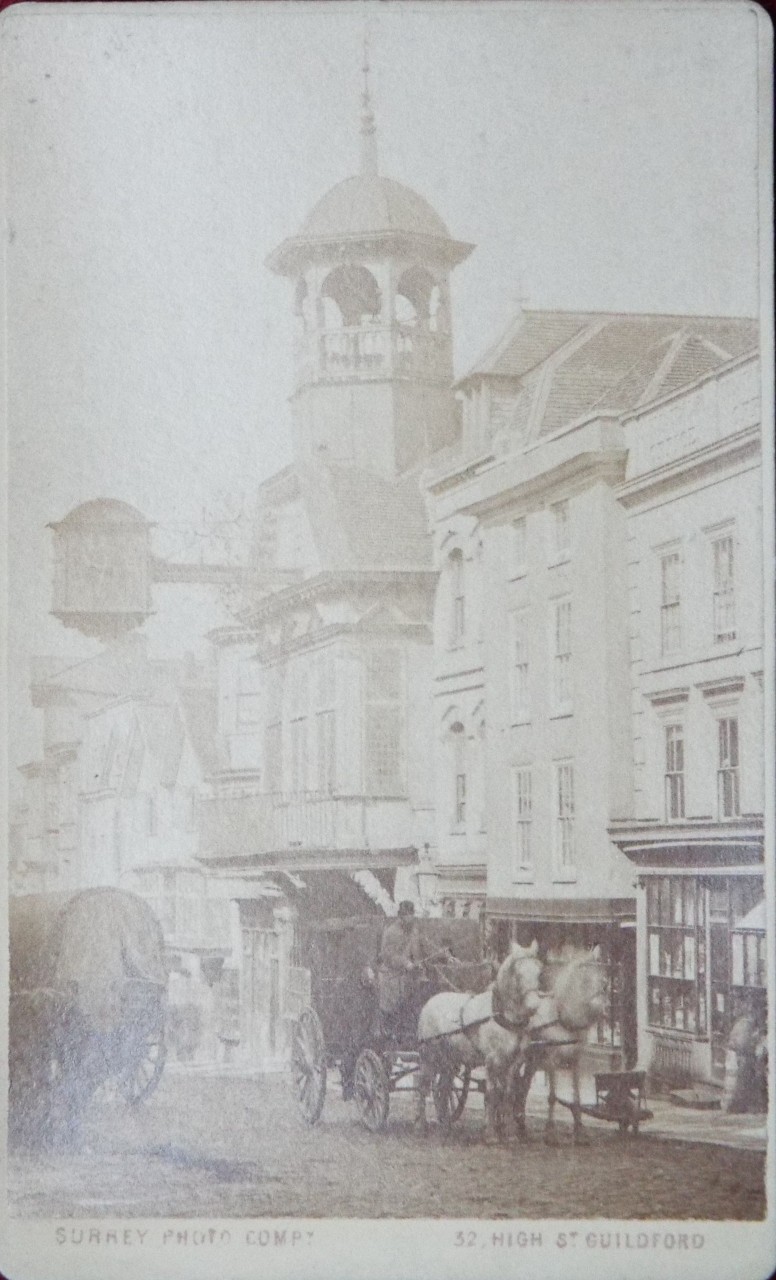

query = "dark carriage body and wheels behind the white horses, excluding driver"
(291, 916), (490, 1132)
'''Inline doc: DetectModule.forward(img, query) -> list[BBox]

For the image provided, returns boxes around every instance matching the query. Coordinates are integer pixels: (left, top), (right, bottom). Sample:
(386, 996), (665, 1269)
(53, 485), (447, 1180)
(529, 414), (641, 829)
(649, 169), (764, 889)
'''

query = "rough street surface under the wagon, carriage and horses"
(9, 1071), (764, 1219)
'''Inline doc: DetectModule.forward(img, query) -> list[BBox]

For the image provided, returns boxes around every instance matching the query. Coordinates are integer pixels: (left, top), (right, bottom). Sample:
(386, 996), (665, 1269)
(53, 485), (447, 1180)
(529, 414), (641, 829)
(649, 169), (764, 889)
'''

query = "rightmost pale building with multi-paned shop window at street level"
(611, 351), (766, 1084)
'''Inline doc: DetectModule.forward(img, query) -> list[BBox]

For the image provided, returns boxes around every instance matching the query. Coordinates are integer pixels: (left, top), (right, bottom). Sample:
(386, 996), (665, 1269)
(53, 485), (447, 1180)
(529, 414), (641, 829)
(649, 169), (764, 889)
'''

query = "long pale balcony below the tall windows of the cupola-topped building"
(197, 791), (421, 865)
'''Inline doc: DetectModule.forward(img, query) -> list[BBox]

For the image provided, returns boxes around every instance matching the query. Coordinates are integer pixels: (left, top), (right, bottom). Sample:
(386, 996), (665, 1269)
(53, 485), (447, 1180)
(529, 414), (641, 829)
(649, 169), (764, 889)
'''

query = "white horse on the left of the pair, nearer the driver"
(415, 941), (542, 1142)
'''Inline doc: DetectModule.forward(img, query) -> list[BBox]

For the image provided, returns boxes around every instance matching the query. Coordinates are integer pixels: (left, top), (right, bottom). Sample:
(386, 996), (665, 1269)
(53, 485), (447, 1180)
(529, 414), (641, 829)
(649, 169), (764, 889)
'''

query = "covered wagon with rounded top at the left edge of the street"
(9, 888), (166, 1139)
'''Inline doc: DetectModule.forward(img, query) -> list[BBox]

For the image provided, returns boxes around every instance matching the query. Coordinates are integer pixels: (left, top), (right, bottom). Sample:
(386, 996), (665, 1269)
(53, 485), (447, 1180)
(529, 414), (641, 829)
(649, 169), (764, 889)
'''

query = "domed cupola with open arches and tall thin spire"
(268, 48), (473, 475)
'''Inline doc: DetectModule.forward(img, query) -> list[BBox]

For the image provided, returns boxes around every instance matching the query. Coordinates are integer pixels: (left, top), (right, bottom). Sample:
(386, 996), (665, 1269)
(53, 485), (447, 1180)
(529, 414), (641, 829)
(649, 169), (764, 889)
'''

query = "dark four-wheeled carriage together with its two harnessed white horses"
(291, 918), (651, 1142)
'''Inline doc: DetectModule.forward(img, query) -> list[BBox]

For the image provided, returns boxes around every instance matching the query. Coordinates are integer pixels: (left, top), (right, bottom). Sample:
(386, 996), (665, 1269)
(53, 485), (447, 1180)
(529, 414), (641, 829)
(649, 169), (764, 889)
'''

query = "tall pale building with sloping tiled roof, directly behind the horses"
(428, 312), (756, 1065)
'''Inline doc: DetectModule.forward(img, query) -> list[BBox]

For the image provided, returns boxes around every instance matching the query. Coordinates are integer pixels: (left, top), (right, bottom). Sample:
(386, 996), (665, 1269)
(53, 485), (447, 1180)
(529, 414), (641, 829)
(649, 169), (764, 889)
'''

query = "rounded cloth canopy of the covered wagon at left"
(10, 888), (166, 1029)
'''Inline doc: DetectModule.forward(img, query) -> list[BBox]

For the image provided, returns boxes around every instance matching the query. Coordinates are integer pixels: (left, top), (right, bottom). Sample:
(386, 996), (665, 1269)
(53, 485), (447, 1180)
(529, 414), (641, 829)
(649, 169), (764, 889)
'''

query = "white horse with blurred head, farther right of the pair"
(510, 946), (606, 1144)
